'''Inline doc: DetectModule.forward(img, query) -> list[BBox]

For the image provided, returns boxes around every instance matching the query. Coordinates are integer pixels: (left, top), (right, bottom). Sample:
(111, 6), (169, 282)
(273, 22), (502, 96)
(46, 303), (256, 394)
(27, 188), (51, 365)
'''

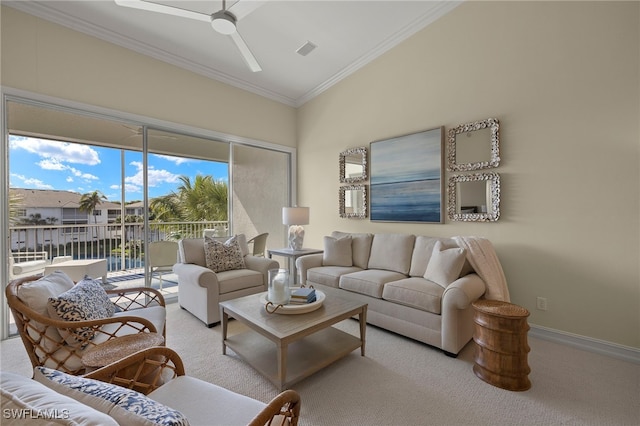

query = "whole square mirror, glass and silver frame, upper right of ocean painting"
(448, 118), (500, 171)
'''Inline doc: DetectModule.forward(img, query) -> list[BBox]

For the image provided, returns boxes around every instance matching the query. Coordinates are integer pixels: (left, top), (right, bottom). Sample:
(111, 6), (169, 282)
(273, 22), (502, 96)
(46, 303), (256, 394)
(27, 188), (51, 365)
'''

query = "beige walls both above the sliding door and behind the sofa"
(1, 2), (640, 348)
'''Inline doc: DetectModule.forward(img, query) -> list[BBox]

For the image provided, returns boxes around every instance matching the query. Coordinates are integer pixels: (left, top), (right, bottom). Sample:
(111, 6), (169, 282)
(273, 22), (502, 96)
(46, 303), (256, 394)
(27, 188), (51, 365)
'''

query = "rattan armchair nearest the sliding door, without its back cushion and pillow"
(6, 275), (166, 375)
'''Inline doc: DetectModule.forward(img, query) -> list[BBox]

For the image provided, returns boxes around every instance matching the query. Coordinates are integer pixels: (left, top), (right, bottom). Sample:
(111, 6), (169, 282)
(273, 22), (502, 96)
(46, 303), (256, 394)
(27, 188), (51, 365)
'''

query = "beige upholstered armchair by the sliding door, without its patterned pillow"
(173, 235), (280, 327)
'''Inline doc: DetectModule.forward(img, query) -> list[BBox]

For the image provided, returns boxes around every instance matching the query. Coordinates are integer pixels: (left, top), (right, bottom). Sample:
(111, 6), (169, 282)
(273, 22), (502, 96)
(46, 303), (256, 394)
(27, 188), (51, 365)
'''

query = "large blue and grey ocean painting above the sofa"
(370, 128), (443, 223)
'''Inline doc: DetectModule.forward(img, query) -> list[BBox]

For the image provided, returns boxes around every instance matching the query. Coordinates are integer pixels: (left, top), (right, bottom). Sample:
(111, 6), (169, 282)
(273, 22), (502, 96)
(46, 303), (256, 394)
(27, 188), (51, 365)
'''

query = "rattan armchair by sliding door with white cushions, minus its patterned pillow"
(6, 271), (166, 375)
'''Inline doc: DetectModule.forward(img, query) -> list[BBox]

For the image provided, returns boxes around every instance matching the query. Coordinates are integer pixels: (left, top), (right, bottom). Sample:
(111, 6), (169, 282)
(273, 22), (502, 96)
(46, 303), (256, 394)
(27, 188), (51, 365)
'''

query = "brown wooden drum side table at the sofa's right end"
(473, 300), (531, 391)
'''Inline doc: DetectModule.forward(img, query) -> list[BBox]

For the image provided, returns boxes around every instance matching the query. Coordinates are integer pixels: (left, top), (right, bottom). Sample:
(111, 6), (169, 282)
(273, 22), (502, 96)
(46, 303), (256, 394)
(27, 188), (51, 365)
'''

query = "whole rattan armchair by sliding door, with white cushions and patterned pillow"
(6, 271), (166, 374)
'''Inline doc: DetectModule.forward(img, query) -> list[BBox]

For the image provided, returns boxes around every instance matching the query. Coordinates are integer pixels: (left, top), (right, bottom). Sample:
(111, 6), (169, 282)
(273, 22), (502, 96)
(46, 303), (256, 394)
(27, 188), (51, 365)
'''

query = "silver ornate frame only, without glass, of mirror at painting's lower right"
(448, 172), (500, 222)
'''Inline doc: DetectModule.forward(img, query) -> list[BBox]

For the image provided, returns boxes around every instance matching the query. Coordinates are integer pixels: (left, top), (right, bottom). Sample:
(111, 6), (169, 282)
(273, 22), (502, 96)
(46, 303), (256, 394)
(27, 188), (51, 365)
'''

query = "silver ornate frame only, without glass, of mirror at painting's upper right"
(447, 118), (500, 172)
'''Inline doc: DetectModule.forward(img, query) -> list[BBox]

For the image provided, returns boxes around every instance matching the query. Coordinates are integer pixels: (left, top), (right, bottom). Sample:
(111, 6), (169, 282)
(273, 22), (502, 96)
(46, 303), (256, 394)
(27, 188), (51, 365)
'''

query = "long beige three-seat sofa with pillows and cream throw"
(296, 232), (509, 356)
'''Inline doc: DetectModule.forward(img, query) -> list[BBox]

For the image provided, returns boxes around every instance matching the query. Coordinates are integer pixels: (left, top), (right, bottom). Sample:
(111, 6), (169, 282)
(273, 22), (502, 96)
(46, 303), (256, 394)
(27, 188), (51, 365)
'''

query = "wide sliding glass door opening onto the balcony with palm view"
(0, 96), (293, 338)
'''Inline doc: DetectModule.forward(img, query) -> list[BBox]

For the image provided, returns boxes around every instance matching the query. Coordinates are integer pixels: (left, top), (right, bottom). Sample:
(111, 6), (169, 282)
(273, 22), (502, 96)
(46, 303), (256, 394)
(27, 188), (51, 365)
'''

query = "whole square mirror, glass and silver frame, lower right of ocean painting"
(448, 173), (500, 222)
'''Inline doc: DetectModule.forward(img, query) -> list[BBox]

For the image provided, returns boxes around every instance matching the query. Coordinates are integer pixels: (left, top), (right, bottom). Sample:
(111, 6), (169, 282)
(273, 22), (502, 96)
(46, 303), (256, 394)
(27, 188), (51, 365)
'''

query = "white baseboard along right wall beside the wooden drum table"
(529, 324), (640, 364)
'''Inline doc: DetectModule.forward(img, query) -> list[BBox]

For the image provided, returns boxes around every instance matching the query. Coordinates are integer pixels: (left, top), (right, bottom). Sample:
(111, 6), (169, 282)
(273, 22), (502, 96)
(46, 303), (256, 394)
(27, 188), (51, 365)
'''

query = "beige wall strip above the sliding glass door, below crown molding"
(1, 7), (296, 147)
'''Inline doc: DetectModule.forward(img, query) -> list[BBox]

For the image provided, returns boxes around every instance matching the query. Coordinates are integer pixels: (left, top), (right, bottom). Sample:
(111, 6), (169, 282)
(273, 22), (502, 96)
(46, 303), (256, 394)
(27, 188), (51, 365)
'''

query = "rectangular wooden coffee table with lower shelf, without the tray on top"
(220, 294), (367, 391)
